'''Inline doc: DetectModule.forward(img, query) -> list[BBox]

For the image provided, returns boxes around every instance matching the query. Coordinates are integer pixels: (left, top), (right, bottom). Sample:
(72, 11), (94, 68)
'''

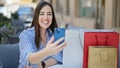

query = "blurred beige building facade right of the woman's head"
(46, 0), (120, 32)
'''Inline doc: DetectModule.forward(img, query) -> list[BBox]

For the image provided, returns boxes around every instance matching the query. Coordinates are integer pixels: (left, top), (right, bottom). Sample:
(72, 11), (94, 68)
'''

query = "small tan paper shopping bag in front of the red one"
(88, 46), (117, 68)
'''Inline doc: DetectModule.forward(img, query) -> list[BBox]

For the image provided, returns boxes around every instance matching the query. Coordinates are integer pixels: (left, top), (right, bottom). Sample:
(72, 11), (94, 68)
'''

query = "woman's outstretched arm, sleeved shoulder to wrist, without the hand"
(19, 32), (49, 68)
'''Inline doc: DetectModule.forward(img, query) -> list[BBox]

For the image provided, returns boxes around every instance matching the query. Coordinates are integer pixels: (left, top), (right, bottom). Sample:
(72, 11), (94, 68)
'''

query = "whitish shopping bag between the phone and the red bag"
(63, 29), (83, 68)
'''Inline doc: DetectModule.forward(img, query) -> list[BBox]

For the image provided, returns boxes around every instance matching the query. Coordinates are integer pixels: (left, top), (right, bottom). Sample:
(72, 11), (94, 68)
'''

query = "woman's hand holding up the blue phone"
(45, 36), (66, 56)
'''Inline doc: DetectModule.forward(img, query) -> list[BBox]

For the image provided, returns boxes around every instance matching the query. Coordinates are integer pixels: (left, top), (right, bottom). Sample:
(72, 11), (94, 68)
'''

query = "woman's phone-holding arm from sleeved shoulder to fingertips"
(19, 33), (66, 68)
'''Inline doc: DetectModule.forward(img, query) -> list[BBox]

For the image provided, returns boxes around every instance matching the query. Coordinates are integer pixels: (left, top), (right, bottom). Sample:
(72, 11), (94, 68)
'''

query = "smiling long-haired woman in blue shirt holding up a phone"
(19, 1), (66, 68)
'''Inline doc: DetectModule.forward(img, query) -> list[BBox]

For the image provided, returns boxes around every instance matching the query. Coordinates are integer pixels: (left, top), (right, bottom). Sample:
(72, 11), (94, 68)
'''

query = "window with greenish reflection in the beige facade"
(76, 0), (96, 18)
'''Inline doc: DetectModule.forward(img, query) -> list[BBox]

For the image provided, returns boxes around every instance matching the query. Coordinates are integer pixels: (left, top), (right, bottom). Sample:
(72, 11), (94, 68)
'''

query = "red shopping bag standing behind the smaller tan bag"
(83, 32), (119, 68)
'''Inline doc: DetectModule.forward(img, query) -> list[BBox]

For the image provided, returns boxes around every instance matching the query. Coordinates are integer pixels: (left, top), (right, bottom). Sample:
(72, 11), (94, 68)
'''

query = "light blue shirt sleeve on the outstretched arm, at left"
(19, 32), (37, 68)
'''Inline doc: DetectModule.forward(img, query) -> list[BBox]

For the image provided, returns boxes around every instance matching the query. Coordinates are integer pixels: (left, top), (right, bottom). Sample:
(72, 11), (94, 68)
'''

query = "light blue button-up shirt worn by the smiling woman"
(18, 27), (62, 68)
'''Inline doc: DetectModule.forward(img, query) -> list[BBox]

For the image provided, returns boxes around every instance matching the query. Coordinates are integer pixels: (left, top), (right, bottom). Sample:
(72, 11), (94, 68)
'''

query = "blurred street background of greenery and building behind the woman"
(0, 0), (120, 44)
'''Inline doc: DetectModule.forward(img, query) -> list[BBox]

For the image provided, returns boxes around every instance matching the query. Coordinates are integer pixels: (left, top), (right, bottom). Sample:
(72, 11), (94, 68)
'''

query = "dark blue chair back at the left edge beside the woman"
(0, 44), (20, 68)
